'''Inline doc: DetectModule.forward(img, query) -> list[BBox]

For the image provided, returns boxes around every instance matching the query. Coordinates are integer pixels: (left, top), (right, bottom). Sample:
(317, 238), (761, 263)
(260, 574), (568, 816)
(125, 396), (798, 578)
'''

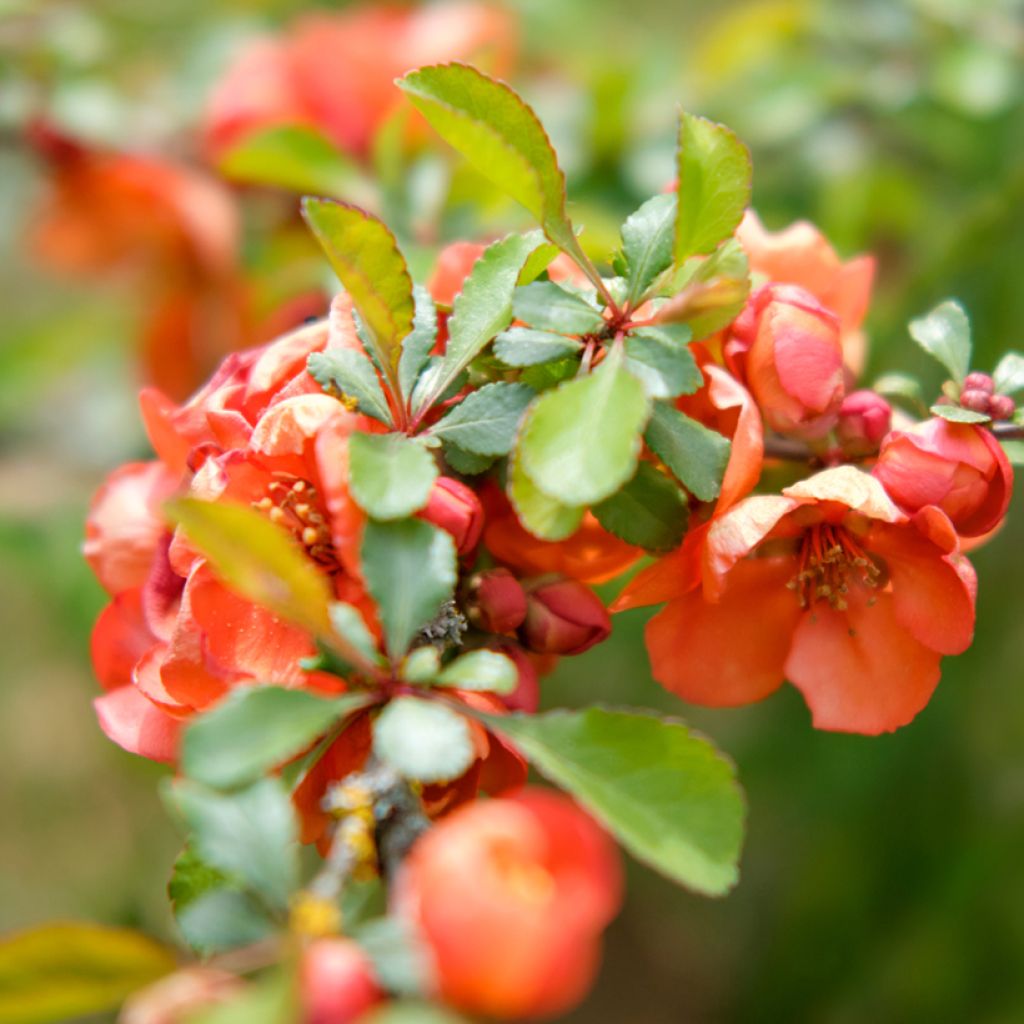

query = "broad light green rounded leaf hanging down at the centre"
(518, 346), (650, 506)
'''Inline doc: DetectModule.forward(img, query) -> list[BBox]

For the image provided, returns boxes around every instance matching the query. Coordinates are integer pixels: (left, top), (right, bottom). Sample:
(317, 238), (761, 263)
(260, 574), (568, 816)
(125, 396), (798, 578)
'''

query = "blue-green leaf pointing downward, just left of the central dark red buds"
(362, 519), (456, 659)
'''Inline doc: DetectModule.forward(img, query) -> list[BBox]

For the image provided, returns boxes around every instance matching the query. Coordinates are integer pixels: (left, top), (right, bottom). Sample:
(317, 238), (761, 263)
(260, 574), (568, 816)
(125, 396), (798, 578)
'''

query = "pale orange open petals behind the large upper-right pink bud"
(736, 210), (874, 377)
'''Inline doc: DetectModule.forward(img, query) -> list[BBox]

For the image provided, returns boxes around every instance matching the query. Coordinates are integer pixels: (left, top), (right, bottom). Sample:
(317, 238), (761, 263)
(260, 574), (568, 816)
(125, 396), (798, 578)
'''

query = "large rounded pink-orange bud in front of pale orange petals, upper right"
(725, 285), (844, 440)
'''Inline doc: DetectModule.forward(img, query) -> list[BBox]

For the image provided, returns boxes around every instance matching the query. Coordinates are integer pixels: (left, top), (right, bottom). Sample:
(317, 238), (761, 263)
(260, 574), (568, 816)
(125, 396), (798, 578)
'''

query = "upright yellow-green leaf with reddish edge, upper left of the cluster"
(302, 197), (415, 394)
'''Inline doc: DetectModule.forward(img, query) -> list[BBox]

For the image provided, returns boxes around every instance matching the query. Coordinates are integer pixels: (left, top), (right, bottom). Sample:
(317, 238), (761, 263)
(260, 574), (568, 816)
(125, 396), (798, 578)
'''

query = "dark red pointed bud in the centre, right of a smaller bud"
(519, 580), (611, 654)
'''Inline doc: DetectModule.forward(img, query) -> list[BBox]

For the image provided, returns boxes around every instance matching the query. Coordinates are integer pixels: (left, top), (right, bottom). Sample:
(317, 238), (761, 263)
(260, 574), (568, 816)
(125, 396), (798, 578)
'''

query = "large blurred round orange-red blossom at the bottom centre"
(395, 790), (622, 1019)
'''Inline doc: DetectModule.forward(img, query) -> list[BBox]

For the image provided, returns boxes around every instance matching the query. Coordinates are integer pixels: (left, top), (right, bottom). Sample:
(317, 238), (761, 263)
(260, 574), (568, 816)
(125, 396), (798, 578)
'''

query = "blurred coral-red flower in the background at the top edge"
(204, 2), (516, 160)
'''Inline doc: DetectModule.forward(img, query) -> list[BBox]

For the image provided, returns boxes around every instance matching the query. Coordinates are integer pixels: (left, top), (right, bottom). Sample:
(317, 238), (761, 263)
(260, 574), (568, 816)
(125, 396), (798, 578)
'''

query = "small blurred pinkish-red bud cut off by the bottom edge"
(299, 938), (381, 1024)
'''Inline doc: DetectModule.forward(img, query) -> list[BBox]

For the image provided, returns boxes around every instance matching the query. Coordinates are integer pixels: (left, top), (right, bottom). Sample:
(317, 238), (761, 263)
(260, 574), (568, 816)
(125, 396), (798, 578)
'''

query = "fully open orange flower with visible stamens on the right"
(646, 466), (975, 734)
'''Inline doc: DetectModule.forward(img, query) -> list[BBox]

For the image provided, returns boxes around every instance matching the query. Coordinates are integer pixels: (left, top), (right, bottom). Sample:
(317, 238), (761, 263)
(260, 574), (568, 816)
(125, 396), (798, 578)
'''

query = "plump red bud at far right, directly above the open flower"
(872, 417), (1014, 537)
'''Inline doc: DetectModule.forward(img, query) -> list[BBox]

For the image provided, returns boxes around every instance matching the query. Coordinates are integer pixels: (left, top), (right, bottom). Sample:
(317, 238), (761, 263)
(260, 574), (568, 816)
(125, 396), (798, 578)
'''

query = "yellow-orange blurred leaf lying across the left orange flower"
(166, 498), (331, 634)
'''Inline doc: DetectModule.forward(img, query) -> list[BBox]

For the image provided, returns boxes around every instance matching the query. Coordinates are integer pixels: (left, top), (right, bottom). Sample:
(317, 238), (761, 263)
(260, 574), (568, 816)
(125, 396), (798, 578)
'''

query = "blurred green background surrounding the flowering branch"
(0, 0), (1024, 1024)
